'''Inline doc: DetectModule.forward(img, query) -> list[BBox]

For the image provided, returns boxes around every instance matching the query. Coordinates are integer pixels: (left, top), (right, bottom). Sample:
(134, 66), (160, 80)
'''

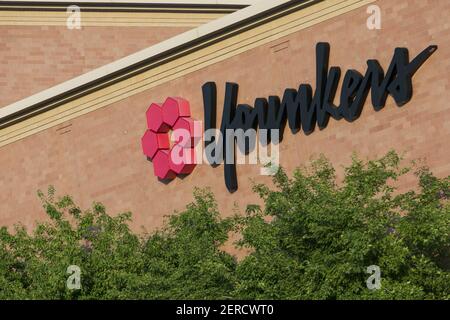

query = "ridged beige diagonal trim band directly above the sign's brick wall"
(0, 0), (375, 146)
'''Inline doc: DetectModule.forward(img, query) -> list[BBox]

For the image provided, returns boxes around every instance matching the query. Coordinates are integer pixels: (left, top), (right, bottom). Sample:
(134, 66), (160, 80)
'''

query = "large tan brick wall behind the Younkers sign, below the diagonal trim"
(0, 0), (450, 229)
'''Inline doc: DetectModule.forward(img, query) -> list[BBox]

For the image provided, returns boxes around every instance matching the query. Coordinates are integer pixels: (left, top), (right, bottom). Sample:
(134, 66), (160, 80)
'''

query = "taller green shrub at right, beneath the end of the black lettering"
(235, 152), (450, 299)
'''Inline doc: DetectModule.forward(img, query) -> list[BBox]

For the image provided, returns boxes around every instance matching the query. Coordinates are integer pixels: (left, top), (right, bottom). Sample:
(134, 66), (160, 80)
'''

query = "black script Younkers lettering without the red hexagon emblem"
(144, 42), (437, 192)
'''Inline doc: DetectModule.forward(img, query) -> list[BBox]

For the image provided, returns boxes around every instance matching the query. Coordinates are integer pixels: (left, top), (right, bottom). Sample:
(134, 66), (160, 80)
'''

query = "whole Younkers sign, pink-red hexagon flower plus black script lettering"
(142, 42), (437, 192)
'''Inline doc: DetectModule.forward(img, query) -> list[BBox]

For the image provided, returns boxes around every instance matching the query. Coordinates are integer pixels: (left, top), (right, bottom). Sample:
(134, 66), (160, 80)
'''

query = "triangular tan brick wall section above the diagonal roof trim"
(0, 25), (191, 107)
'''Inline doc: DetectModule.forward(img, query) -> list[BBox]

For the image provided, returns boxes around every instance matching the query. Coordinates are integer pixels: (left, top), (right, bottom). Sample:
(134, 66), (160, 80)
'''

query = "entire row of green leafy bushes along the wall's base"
(0, 152), (450, 299)
